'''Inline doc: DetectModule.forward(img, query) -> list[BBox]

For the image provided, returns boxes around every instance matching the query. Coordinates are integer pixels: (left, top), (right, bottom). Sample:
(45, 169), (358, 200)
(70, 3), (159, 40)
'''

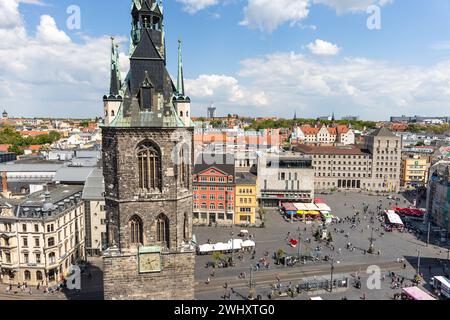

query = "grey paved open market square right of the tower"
(194, 192), (449, 299)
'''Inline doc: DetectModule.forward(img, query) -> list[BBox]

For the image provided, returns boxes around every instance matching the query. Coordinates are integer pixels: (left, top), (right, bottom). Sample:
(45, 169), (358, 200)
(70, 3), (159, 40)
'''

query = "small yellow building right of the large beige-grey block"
(401, 155), (430, 188)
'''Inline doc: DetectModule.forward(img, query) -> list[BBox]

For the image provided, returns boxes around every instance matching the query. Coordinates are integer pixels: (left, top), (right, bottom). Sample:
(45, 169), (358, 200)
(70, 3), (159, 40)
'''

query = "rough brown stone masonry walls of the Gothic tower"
(103, 127), (195, 300)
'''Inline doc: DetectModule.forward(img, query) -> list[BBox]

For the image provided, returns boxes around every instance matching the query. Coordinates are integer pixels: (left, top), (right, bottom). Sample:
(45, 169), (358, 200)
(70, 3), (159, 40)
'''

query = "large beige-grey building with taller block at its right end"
(294, 128), (401, 191)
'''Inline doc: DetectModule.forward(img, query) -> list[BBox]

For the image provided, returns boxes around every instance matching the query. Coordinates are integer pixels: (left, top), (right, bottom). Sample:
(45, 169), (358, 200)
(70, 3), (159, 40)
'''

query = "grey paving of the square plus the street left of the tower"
(0, 192), (450, 300)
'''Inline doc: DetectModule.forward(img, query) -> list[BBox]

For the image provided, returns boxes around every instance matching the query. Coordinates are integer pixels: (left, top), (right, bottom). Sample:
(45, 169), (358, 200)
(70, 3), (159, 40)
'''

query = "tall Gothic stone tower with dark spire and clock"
(102, 0), (195, 300)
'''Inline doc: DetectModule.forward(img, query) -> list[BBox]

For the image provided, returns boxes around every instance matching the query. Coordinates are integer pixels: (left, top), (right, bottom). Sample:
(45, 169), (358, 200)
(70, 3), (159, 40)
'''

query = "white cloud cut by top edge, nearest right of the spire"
(240, 0), (309, 32)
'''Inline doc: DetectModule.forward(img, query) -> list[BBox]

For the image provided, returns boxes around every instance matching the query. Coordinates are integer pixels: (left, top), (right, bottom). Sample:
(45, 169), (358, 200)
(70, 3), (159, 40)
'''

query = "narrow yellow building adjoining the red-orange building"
(234, 172), (258, 224)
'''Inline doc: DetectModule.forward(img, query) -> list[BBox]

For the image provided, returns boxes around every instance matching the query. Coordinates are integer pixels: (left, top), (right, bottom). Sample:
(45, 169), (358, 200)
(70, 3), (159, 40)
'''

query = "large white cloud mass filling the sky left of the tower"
(0, 0), (128, 117)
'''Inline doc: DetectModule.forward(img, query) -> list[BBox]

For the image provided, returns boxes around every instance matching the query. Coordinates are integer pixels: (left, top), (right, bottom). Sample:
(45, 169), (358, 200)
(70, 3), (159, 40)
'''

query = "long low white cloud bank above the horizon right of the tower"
(188, 52), (450, 120)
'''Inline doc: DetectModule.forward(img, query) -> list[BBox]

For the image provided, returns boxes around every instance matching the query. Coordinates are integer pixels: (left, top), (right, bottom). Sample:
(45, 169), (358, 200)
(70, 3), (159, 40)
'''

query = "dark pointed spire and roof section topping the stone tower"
(105, 0), (192, 127)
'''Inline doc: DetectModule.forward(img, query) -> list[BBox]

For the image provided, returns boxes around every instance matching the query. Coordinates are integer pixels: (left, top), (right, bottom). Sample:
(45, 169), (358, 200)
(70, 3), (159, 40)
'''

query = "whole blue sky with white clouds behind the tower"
(0, 0), (450, 120)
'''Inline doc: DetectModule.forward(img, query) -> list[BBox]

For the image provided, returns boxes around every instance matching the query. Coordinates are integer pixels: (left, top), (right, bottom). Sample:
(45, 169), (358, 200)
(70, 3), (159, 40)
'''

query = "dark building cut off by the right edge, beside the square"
(427, 161), (450, 236)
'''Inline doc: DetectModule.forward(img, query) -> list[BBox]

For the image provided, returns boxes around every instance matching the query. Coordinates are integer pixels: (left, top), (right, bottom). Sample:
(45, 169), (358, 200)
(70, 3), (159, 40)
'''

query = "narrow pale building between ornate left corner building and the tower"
(82, 168), (107, 256)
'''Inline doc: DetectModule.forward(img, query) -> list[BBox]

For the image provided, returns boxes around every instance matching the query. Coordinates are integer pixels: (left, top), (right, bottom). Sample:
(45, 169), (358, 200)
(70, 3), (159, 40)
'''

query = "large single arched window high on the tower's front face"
(137, 144), (161, 191)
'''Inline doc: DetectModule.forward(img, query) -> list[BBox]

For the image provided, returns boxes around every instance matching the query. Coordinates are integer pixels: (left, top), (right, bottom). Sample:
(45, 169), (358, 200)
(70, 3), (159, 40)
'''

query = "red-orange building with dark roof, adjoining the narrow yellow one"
(193, 154), (236, 224)
